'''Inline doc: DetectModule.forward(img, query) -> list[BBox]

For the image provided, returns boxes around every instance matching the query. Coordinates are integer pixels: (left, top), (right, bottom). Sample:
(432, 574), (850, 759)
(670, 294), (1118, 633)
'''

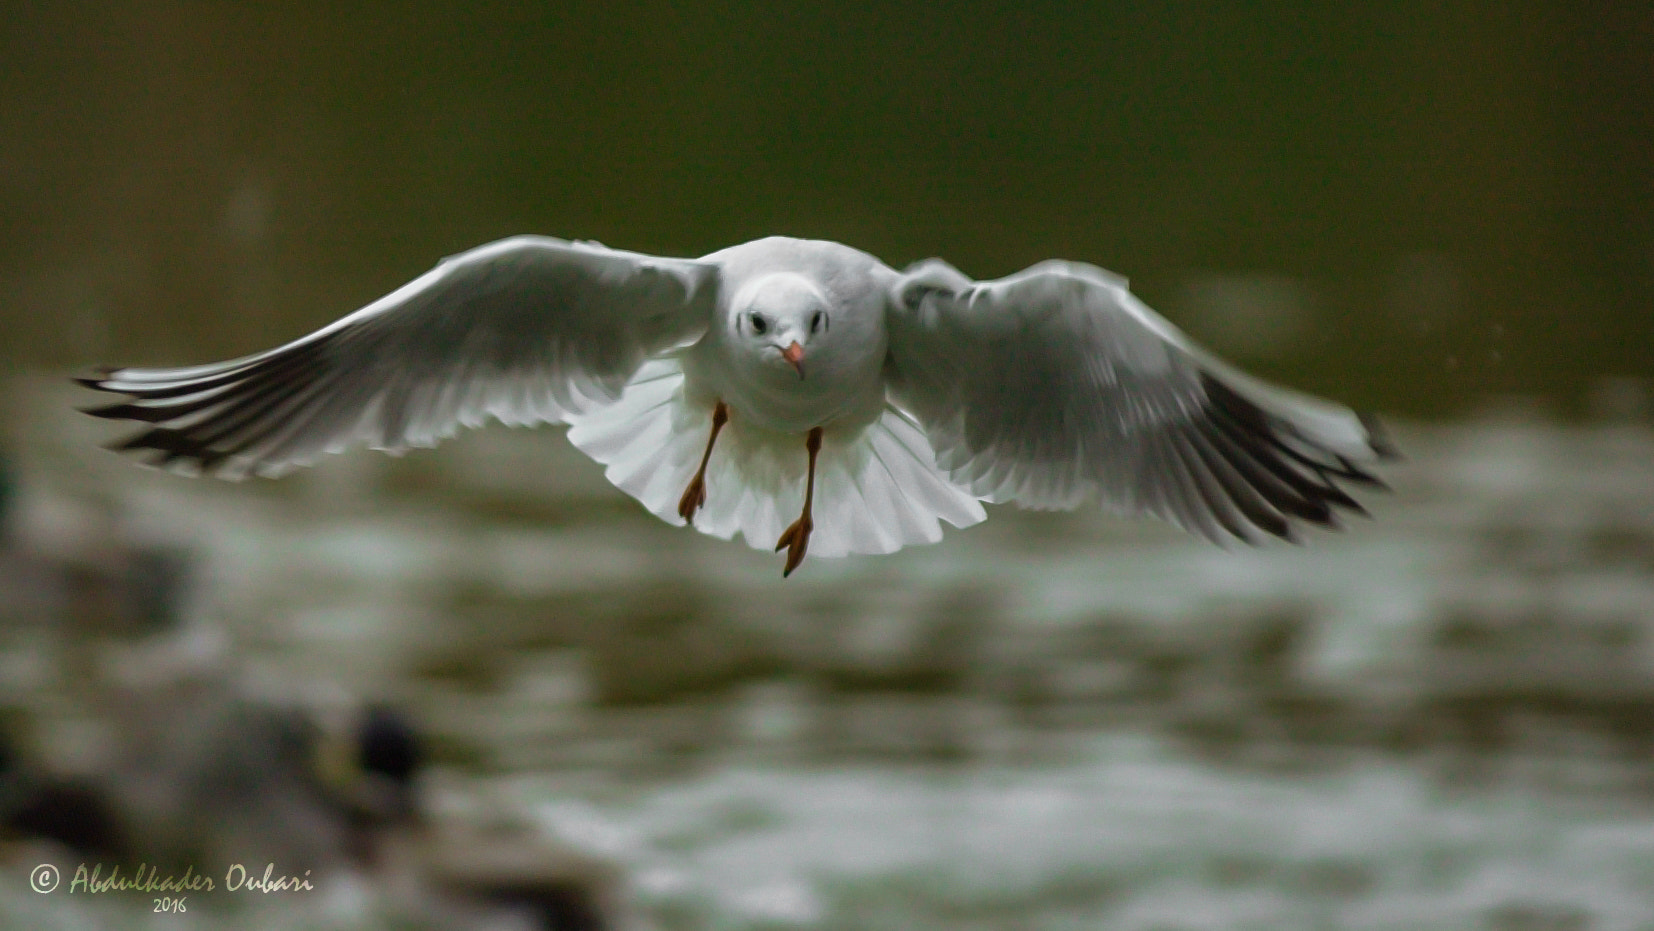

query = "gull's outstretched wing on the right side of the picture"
(888, 260), (1393, 542)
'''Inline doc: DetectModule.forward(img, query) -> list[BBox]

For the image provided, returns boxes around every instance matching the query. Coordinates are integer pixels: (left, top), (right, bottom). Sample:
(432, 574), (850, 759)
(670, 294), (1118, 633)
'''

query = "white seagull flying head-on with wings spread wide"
(78, 236), (1396, 577)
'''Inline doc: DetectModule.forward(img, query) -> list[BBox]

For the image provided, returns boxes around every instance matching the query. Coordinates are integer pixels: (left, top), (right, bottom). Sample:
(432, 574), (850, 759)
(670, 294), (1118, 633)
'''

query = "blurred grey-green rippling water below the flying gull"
(0, 380), (1654, 931)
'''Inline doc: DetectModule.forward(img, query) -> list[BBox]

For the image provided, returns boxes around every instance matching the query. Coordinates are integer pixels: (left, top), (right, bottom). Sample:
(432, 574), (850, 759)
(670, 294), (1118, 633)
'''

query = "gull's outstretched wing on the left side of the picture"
(81, 236), (718, 478)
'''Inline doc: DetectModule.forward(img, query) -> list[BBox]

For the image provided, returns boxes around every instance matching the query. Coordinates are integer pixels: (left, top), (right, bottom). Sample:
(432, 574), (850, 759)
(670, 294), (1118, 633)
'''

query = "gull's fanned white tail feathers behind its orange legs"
(569, 357), (986, 557)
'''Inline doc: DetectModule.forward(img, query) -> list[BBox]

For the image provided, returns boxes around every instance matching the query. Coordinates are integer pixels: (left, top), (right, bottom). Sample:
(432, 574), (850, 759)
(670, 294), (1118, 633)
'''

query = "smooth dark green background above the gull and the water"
(0, 0), (1654, 415)
